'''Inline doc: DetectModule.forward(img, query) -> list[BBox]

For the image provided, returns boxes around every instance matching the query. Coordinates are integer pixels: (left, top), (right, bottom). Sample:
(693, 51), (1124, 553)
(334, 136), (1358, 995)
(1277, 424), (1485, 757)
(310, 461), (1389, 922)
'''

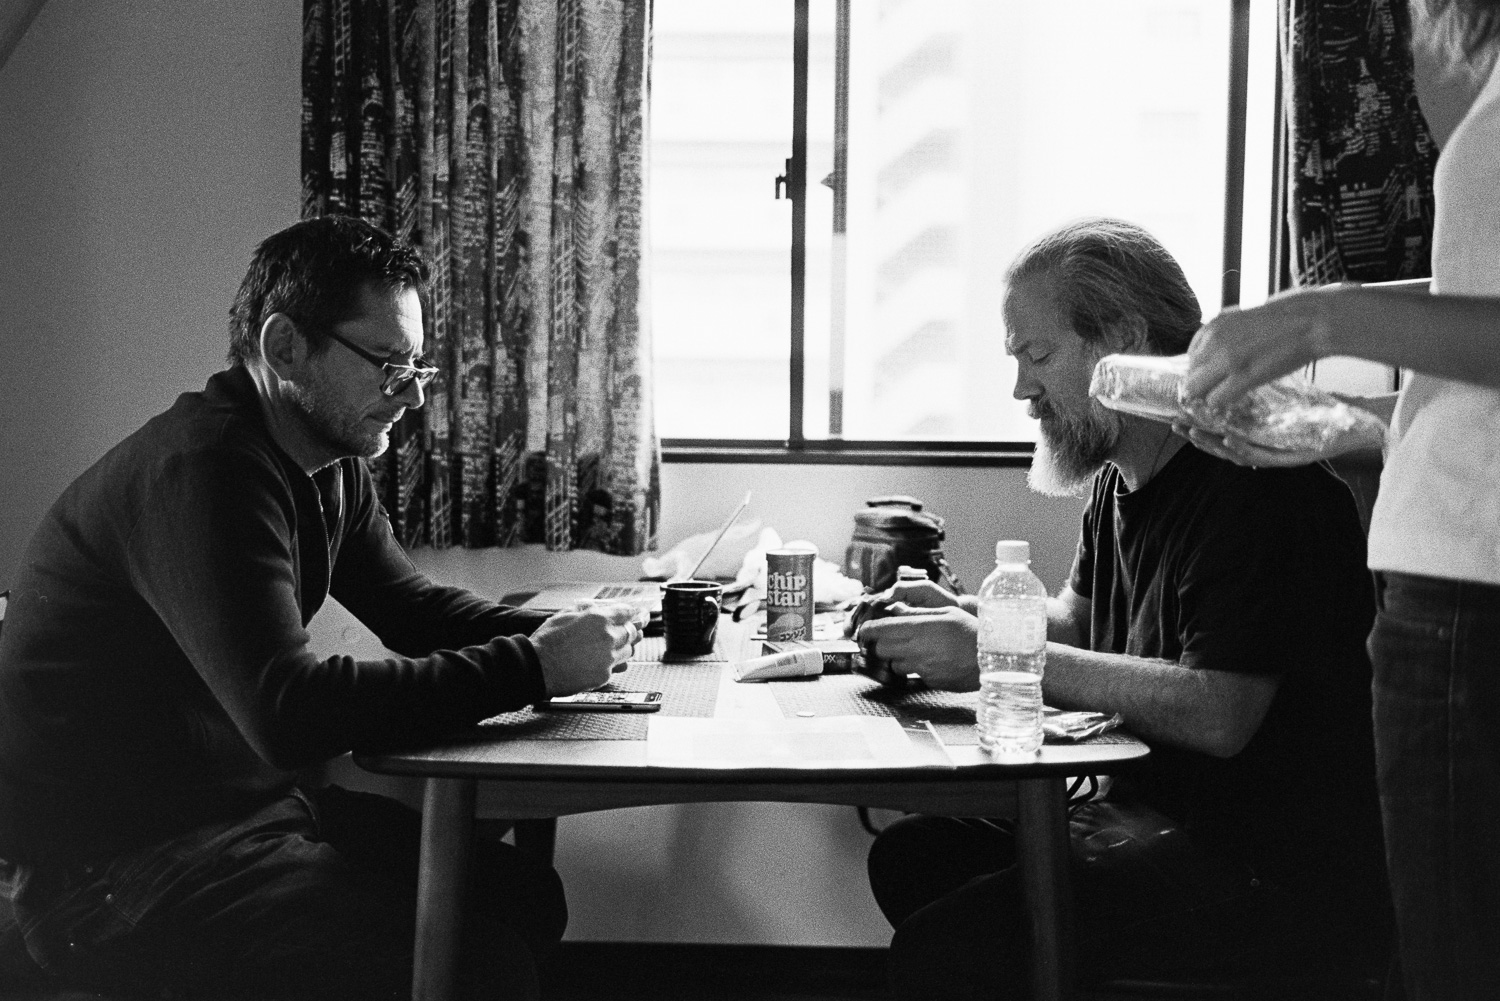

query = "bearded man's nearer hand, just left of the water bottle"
(857, 605), (980, 692)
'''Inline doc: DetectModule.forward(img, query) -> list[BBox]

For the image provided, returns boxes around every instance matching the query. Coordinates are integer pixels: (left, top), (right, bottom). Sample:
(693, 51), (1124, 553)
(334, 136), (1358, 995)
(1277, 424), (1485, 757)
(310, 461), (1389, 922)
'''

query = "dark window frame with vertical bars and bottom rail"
(662, 0), (1260, 468)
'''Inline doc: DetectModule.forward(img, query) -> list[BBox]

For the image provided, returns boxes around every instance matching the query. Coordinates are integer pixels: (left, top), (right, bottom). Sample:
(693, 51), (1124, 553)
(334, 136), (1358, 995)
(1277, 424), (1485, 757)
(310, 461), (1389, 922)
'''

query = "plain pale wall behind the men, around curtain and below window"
(0, 0), (1079, 945)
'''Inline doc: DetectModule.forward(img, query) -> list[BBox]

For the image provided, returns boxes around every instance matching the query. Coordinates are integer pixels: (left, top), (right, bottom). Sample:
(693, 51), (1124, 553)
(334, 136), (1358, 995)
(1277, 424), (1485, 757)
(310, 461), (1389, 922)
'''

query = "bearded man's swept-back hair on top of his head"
(1005, 219), (1203, 354)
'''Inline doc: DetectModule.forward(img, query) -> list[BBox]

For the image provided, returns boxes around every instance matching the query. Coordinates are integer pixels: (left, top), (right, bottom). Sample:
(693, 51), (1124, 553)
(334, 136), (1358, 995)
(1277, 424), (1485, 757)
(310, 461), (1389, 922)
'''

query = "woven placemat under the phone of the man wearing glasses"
(480, 662), (720, 740)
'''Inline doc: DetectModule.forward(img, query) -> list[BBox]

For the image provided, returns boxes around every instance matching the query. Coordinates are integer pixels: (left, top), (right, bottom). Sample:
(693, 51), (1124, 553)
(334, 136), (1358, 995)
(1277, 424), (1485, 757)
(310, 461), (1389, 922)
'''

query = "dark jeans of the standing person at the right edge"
(1370, 573), (1500, 1001)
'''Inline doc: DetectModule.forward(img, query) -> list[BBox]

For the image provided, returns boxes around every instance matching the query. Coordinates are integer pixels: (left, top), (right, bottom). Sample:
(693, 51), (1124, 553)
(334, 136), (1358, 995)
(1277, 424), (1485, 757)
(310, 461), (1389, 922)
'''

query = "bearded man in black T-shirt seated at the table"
(860, 219), (1389, 998)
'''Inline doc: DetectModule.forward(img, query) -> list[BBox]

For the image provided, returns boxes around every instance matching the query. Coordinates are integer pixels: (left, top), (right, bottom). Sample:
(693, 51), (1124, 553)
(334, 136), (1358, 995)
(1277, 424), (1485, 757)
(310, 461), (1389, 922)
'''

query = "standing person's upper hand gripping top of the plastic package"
(1182, 285), (1350, 411)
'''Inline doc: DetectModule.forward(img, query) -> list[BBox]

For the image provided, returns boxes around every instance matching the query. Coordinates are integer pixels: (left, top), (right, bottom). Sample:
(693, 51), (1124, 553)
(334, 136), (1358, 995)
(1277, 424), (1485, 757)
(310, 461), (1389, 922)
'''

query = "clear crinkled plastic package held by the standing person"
(1089, 354), (1386, 453)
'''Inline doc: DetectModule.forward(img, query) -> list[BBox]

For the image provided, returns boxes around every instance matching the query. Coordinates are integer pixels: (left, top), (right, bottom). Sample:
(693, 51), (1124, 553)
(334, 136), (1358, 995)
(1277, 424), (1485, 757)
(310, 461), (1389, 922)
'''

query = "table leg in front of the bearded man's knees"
(1016, 779), (1076, 1001)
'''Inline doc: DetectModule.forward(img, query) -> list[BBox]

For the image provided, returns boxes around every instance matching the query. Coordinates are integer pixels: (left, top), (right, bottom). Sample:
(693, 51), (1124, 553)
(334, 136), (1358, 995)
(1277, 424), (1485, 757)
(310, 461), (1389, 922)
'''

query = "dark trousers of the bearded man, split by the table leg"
(870, 801), (1371, 1001)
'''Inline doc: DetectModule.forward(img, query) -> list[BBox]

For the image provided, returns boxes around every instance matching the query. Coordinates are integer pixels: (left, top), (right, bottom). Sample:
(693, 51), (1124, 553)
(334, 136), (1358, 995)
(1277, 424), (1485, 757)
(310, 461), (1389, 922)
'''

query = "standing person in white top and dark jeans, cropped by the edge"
(1184, 0), (1500, 1001)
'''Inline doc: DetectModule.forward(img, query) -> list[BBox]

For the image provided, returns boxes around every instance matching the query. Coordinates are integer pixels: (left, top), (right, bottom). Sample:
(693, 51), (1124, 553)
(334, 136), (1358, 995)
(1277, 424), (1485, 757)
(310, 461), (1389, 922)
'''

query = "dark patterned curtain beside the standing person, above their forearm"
(1281, 0), (1437, 285)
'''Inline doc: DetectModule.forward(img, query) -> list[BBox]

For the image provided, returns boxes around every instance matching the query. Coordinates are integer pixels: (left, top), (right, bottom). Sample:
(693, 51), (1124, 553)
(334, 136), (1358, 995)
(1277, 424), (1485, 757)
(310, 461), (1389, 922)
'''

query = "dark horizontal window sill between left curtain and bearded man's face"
(662, 438), (1034, 468)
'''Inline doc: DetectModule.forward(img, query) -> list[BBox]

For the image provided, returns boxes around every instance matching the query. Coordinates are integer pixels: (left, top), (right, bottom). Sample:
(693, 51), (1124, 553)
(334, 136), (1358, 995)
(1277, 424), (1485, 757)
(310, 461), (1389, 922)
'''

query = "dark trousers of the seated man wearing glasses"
(2, 786), (567, 1001)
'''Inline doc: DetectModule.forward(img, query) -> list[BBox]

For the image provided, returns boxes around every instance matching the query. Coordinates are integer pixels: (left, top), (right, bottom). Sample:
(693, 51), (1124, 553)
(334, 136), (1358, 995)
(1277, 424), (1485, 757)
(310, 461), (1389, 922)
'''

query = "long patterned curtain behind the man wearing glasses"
(302, 0), (660, 555)
